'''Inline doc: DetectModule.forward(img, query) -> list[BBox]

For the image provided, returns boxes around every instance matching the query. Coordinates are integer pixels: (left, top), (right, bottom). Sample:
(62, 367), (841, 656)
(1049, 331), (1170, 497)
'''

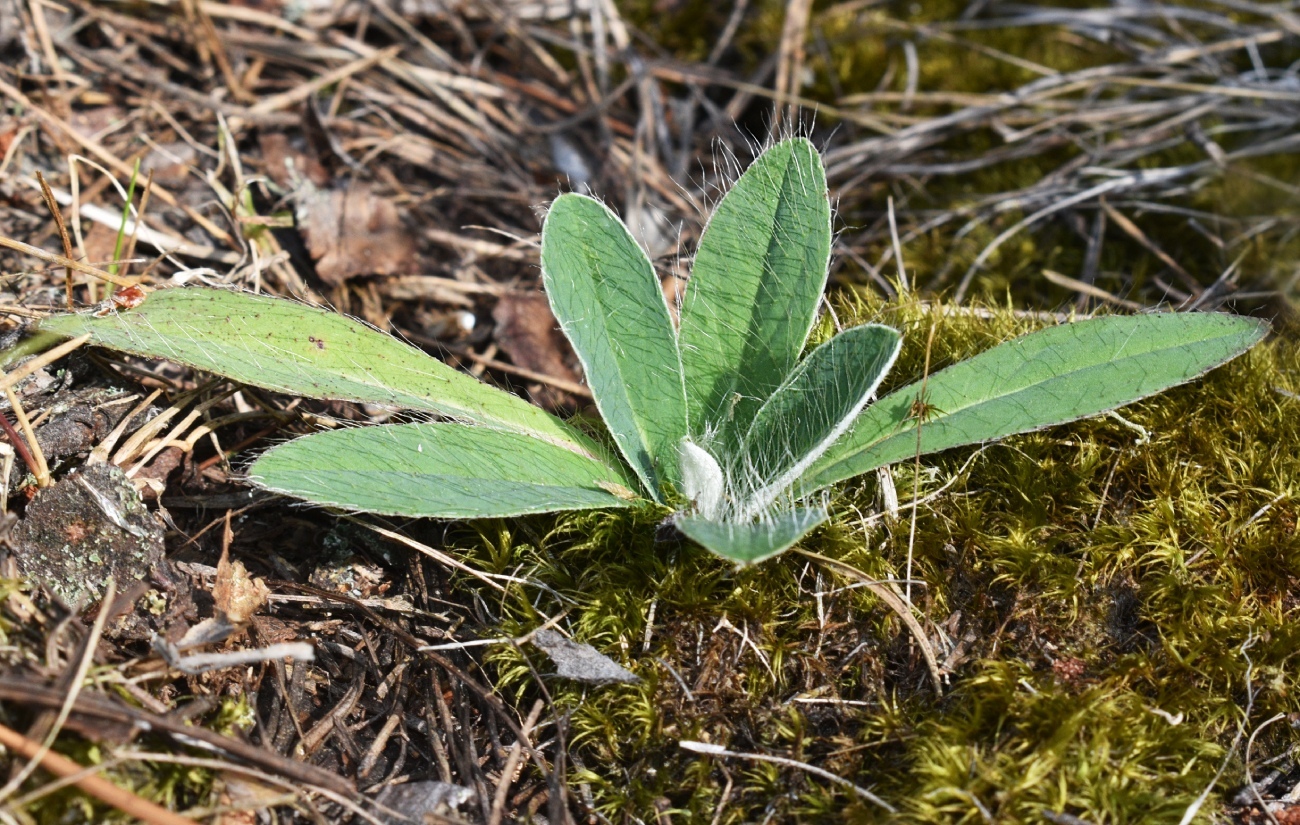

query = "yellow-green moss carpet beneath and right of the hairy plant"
(444, 295), (1300, 822)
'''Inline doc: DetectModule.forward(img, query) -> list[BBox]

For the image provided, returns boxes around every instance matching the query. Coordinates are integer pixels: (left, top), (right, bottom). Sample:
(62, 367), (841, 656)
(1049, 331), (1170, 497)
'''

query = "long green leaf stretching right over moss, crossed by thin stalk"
(800, 313), (1269, 492)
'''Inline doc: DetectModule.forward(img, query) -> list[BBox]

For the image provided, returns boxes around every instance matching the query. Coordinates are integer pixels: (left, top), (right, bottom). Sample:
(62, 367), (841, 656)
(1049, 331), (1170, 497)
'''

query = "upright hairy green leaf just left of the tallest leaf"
(542, 194), (686, 500)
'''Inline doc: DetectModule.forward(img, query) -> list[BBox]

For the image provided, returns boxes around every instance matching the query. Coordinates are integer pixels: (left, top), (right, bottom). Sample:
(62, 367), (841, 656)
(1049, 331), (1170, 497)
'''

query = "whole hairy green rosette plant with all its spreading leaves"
(42, 139), (1268, 564)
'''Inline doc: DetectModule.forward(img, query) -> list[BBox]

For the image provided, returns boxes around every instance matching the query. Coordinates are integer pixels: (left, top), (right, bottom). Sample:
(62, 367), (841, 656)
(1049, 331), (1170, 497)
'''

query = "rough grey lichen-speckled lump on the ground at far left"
(13, 465), (164, 604)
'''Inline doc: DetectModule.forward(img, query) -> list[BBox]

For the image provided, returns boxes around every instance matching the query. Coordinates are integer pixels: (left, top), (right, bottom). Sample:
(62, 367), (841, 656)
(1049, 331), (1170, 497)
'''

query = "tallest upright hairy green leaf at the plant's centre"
(681, 138), (831, 443)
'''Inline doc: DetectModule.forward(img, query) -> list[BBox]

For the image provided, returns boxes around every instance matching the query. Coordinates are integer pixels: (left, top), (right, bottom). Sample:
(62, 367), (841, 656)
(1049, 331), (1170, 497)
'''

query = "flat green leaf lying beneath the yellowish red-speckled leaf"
(248, 424), (631, 518)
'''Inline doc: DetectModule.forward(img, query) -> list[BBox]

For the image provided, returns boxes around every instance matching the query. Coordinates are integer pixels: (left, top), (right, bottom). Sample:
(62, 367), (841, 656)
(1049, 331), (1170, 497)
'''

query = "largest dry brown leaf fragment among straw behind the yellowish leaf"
(298, 183), (415, 286)
